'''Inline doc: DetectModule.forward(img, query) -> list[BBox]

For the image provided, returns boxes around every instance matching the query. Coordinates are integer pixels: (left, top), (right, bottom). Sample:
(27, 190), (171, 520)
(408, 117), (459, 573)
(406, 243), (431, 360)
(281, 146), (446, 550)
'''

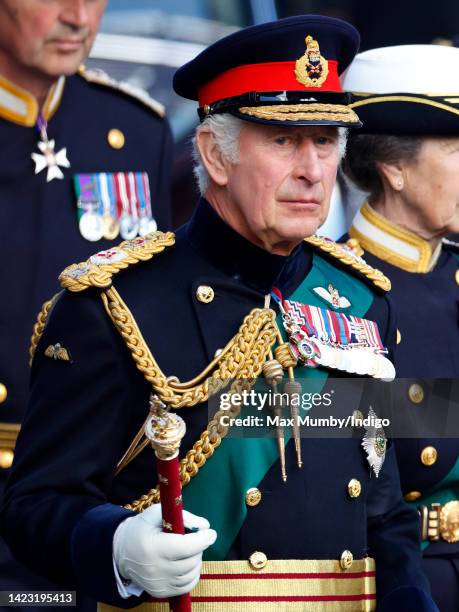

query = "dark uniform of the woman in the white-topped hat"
(344, 210), (459, 611)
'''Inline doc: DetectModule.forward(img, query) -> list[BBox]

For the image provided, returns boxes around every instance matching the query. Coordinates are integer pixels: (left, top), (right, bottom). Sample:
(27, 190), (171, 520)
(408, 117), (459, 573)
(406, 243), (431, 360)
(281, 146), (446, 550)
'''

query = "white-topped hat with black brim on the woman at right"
(343, 45), (459, 136)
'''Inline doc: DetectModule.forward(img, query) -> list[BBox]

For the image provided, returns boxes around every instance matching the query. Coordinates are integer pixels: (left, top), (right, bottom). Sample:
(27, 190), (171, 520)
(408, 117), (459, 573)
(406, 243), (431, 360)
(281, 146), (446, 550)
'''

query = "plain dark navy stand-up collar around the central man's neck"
(186, 198), (311, 294)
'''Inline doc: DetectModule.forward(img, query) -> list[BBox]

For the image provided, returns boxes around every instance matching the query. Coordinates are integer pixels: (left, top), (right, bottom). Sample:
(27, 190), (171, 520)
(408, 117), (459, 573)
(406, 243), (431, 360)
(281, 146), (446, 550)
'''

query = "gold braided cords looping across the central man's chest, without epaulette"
(102, 287), (279, 512)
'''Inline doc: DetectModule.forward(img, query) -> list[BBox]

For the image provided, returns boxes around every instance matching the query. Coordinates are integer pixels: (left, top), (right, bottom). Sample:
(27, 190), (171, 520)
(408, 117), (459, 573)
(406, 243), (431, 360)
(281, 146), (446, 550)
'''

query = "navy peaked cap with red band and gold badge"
(174, 15), (360, 127)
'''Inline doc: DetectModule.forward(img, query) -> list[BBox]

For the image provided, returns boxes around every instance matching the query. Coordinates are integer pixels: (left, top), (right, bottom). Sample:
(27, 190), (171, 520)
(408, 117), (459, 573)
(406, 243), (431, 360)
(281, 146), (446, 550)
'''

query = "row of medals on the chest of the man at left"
(74, 172), (157, 242)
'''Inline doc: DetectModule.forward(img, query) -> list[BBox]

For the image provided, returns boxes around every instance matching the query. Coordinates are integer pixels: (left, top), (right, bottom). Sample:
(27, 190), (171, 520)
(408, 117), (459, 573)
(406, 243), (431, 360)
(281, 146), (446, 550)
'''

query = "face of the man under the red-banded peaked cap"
(219, 122), (339, 254)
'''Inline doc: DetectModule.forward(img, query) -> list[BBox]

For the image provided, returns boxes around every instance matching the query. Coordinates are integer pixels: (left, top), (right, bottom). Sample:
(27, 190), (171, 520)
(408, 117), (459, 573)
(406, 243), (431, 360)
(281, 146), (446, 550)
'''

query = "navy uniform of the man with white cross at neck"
(0, 69), (171, 604)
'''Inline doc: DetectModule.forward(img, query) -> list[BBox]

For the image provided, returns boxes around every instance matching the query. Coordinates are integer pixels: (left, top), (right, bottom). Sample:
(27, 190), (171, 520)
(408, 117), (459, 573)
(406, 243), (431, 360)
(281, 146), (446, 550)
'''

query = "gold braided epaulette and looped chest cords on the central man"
(36, 232), (296, 512)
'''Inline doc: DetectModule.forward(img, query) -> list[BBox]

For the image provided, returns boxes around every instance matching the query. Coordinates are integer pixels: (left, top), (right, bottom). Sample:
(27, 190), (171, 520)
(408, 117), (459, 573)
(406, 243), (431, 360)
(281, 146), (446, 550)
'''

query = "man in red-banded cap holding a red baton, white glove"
(1, 15), (437, 612)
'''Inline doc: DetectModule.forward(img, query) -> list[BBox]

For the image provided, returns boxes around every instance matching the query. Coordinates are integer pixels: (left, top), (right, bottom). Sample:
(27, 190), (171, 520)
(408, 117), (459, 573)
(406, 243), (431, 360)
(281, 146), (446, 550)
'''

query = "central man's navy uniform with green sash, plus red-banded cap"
(1, 15), (436, 612)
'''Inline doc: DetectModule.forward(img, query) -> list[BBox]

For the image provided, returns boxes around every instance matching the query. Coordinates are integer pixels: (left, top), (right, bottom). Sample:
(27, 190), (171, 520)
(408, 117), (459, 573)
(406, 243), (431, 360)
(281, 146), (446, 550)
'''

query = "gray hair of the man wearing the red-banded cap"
(192, 113), (349, 195)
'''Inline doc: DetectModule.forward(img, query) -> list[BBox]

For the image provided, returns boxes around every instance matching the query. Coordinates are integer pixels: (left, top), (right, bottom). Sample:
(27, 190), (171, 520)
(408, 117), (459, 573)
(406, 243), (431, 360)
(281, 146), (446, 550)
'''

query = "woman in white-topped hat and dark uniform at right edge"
(344, 45), (459, 612)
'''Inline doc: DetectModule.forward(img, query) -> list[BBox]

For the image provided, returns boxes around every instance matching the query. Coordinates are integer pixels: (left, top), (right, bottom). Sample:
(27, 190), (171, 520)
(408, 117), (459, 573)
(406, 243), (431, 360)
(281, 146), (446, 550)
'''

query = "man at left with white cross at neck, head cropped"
(0, 0), (171, 604)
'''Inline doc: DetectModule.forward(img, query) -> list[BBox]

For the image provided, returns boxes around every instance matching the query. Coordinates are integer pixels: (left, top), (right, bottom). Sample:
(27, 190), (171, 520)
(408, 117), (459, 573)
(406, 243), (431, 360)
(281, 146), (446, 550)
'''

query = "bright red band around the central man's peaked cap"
(199, 60), (343, 106)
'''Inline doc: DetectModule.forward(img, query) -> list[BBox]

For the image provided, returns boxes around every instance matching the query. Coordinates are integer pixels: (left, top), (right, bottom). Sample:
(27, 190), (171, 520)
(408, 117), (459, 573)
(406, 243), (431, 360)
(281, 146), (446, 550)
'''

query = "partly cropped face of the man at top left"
(0, 0), (107, 77)
